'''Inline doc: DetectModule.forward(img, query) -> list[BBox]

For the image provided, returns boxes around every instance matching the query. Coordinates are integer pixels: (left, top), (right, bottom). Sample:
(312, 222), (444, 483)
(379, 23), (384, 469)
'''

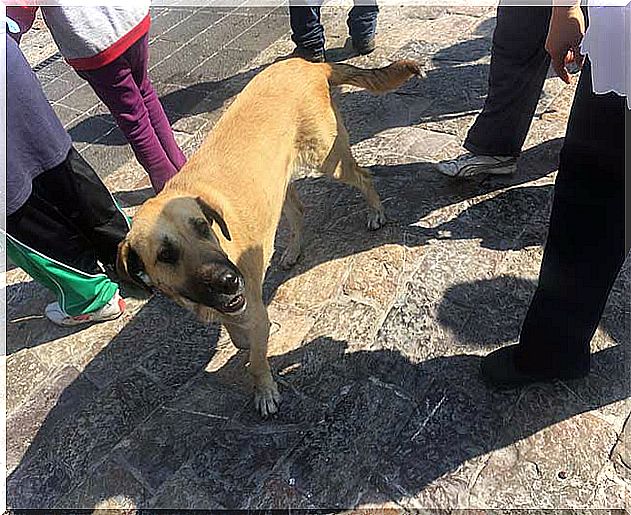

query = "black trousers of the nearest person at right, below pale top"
(517, 63), (629, 377)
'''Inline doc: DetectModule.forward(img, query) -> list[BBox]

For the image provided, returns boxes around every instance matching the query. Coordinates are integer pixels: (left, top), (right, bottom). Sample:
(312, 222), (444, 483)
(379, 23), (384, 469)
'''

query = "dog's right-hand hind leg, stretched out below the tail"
(321, 108), (386, 230)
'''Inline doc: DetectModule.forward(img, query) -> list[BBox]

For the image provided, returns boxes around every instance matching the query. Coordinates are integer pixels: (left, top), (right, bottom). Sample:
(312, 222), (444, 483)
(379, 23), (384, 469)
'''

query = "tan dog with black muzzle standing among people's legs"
(118, 59), (420, 416)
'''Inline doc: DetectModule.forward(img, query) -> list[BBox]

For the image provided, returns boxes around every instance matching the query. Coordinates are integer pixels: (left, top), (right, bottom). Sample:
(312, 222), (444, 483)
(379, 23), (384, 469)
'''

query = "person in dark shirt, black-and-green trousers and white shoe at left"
(3, 34), (129, 326)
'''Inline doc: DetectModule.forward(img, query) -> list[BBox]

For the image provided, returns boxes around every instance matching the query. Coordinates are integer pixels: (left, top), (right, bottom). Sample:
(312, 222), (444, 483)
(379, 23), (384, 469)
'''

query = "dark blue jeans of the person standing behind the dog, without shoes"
(289, 1), (379, 50)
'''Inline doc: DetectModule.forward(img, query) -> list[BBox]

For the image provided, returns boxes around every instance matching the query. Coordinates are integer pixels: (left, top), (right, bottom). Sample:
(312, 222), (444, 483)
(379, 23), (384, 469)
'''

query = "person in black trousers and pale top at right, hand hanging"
(481, 0), (631, 387)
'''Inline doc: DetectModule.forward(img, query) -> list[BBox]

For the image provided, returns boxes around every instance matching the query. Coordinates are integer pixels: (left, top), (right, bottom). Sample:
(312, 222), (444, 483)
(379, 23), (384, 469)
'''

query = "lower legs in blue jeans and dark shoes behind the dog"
(289, 0), (379, 62)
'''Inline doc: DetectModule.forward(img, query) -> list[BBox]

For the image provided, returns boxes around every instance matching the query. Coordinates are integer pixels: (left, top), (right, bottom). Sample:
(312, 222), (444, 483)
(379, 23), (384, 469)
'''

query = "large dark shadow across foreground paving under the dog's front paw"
(7, 278), (628, 512)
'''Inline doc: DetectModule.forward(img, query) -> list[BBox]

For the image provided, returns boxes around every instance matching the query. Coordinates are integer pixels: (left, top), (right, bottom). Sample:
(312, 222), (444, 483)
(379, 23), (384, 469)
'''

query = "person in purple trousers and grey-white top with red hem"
(7, 0), (186, 193)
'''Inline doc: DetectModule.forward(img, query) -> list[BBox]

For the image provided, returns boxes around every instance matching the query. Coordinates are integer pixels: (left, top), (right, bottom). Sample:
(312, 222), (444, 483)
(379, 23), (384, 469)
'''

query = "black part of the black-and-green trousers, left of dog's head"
(7, 148), (129, 274)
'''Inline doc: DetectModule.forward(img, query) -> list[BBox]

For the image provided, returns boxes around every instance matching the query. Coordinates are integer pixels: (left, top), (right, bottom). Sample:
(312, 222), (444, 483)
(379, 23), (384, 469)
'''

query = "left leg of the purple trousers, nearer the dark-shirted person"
(78, 54), (178, 192)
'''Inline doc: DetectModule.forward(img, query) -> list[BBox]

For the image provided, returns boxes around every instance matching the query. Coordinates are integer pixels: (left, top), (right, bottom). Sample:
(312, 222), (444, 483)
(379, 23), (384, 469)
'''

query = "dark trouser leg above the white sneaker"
(464, 2), (551, 157)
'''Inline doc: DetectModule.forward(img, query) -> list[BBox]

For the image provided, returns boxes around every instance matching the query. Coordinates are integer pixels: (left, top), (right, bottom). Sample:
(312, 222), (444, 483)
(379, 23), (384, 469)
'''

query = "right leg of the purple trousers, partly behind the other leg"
(127, 35), (186, 170)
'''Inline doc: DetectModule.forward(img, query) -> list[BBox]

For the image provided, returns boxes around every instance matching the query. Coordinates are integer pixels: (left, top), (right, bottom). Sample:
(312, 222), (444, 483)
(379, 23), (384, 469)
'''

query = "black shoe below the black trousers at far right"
(480, 345), (588, 389)
